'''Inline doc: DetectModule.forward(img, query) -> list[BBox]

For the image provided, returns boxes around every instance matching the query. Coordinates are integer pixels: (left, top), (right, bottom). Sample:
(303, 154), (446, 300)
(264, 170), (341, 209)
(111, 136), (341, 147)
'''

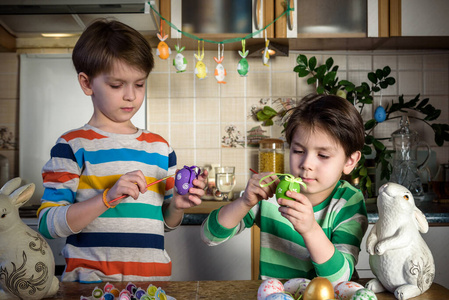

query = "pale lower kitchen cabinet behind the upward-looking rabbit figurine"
(356, 224), (449, 288)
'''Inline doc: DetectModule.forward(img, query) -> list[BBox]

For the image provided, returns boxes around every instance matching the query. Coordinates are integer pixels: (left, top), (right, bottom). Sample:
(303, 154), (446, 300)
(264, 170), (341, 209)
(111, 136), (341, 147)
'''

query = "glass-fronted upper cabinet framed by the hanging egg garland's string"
(160, 0), (297, 39)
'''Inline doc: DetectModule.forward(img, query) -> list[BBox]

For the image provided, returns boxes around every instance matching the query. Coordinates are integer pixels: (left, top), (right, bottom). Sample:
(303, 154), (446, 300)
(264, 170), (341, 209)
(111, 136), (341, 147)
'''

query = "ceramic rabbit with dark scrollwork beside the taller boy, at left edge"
(0, 178), (59, 300)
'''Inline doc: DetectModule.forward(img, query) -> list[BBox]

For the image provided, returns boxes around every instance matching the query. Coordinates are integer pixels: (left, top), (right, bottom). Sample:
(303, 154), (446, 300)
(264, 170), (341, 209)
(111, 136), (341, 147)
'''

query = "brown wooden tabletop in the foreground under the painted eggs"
(46, 279), (449, 300)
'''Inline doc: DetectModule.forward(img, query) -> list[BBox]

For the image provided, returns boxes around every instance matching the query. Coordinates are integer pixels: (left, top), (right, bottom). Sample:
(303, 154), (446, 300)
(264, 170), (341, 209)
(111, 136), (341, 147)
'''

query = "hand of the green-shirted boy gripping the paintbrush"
(243, 172), (279, 207)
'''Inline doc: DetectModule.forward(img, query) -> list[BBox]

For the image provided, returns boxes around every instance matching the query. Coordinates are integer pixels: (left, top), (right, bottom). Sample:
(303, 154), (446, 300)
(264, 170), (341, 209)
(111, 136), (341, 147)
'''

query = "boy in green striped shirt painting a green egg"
(201, 95), (368, 284)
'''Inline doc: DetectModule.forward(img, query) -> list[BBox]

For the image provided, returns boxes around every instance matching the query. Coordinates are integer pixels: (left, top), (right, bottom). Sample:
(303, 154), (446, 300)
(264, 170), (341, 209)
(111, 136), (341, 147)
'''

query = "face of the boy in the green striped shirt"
(290, 126), (360, 205)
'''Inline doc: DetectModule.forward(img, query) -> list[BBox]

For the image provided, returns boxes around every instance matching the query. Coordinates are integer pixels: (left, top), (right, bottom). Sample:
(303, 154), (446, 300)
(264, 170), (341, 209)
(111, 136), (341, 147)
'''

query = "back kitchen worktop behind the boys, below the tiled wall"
(182, 200), (449, 226)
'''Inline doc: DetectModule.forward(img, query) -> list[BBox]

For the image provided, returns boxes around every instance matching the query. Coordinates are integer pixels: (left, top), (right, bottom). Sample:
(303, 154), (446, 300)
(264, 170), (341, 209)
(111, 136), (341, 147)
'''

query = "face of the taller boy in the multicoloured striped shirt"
(80, 61), (147, 131)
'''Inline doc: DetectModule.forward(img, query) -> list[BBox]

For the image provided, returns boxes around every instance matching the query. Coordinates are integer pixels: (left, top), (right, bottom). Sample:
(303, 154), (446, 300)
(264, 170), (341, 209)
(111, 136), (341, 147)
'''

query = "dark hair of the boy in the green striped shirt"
(285, 94), (365, 157)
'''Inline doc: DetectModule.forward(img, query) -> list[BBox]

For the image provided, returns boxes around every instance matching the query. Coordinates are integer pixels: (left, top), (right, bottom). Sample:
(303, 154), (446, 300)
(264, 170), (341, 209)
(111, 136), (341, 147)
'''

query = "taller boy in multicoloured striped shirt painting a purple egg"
(38, 20), (207, 283)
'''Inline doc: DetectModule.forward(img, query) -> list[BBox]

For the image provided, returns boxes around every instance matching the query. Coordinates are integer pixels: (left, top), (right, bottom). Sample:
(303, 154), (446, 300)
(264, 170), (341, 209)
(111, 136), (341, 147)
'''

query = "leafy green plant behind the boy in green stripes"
(257, 54), (449, 196)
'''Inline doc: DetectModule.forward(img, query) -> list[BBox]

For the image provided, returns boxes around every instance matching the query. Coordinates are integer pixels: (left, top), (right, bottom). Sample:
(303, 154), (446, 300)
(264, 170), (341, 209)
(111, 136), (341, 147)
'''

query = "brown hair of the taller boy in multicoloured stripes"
(72, 19), (154, 78)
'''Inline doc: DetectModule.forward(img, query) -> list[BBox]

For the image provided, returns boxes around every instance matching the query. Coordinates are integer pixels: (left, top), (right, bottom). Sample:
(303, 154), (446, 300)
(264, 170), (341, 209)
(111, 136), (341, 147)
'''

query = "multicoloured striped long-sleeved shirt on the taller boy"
(38, 125), (176, 282)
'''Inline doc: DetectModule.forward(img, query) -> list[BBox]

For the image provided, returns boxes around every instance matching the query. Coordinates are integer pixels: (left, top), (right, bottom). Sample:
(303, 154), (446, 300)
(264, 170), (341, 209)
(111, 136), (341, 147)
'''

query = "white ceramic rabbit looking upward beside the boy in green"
(366, 182), (435, 299)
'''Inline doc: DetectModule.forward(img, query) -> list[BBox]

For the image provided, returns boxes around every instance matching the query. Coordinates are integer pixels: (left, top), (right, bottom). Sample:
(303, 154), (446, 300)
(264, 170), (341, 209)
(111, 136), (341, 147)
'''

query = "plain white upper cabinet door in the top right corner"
(401, 0), (449, 36)
